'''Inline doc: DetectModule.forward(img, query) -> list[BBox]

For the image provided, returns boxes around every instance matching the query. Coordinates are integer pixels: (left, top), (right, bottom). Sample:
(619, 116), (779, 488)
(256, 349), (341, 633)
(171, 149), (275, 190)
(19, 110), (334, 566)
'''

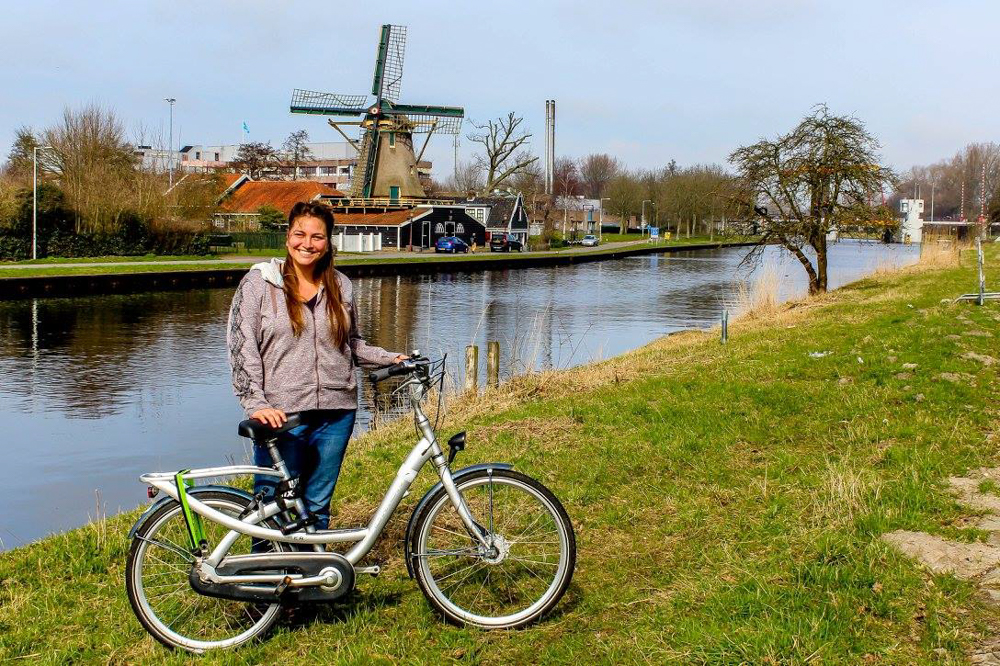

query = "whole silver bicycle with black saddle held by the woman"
(126, 351), (576, 653)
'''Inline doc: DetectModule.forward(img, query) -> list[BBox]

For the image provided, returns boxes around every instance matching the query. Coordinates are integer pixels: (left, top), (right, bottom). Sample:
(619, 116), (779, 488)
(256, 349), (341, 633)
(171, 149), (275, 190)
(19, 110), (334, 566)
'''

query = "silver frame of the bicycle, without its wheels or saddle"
(139, 370), (489, 567)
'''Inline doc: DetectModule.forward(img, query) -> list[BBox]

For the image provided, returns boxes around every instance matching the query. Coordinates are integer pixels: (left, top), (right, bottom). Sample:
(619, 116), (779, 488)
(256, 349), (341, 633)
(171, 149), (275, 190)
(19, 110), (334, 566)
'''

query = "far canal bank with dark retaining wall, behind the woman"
(0, 239), (751, 299)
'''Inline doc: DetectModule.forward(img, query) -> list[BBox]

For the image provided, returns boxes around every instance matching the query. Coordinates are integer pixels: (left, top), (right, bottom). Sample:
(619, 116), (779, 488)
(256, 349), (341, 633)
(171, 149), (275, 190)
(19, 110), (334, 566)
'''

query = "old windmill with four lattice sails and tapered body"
(291, 25), (465, 202)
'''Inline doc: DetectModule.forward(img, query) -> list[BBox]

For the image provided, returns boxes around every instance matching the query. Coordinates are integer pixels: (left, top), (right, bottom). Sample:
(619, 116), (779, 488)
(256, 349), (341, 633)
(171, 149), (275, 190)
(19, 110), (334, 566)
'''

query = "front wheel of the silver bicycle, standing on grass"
(410, 469), (576, 629)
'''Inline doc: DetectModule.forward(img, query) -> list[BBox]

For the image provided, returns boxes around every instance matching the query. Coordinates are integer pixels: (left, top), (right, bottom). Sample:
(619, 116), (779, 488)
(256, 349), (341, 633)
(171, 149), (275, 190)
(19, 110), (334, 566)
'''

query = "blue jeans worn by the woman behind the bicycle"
(253, 409), (357, 530)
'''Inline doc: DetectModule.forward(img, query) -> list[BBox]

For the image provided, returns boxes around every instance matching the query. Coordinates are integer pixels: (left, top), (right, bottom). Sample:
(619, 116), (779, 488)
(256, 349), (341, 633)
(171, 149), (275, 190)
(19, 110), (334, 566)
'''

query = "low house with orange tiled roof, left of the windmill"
(214, 179), (344, 231)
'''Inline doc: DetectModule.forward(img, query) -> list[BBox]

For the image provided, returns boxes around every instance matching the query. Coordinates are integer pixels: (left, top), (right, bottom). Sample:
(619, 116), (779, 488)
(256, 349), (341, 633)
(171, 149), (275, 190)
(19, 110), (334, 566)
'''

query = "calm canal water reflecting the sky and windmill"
(0, 242), (917, 549)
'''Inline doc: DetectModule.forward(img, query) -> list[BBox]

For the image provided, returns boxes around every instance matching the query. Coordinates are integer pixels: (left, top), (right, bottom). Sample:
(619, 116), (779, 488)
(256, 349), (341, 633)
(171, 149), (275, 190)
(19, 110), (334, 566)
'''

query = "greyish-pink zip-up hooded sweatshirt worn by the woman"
(226, 259), (396, 416)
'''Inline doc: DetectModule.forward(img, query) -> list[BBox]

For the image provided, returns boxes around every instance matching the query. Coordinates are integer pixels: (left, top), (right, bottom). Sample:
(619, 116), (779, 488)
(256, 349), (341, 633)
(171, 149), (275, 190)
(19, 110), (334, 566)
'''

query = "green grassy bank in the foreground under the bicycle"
(0, 247), (1000, 664)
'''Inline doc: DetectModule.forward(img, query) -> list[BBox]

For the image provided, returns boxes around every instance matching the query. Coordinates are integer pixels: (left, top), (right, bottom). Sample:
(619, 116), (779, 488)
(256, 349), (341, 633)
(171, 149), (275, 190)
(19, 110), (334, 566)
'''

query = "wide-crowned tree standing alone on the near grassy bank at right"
(729, 105), (895, 294)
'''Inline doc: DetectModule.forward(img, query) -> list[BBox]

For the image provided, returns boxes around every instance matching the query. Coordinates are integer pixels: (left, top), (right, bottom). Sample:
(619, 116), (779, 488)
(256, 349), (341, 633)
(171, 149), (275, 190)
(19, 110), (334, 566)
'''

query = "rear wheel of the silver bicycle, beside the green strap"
(125, 490), (285, 653)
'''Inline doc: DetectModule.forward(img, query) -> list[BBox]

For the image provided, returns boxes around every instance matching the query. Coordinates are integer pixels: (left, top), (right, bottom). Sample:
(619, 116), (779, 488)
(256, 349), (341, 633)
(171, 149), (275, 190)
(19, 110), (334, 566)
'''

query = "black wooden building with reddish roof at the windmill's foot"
(333, 204), (486, 249)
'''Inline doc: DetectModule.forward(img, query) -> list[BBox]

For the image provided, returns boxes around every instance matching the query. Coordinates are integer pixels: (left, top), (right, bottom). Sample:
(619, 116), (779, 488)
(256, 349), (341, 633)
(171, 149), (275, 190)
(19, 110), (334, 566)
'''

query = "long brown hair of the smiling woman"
(281, 201), (350, 349)
